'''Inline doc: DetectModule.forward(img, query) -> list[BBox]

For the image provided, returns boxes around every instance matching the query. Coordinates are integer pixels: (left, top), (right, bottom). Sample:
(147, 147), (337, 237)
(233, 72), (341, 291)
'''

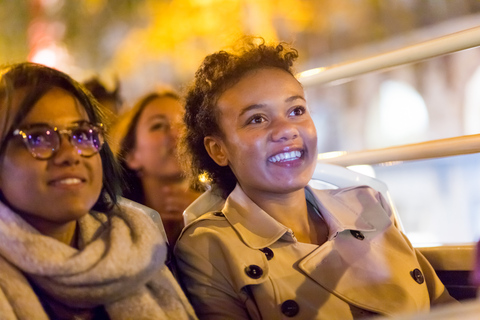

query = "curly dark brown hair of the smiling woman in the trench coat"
(180, 38), (298, 197)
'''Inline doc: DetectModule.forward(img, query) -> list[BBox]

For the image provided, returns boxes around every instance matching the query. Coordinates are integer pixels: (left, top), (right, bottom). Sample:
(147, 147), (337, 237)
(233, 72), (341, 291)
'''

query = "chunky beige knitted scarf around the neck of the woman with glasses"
(0, 200), (196, 320)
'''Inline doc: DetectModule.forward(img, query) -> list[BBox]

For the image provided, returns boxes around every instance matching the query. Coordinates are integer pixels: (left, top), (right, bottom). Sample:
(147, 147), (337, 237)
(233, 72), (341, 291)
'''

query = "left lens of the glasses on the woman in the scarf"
(26, 128), (60, 159)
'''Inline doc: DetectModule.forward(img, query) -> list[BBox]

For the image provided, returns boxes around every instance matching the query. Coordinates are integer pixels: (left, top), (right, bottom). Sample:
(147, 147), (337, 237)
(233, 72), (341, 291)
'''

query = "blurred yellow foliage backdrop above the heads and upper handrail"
(0, 0), (480, 101)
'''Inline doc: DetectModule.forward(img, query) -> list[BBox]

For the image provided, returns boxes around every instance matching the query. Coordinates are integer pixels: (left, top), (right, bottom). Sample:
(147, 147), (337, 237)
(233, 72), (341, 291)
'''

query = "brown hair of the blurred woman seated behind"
(112, 89), (180, 203)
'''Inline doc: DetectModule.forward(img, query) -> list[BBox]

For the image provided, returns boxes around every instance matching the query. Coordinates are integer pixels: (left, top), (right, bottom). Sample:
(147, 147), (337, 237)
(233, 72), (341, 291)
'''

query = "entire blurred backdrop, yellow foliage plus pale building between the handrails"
(0, 0), (480, 244)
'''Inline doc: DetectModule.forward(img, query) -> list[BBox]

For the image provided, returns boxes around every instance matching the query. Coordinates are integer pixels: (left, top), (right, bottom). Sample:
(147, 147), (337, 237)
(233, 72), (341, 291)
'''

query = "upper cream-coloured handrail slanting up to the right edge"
(297, 26), (480, 86)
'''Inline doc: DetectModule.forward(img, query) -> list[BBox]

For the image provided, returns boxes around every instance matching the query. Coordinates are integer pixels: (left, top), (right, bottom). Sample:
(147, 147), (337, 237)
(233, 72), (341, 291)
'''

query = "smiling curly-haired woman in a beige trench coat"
(175, 43), (453, 320)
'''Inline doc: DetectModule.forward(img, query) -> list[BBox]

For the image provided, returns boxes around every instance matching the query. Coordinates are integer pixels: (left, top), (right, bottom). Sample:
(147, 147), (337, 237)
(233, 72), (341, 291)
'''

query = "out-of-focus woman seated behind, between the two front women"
(112, 90), (200, 246)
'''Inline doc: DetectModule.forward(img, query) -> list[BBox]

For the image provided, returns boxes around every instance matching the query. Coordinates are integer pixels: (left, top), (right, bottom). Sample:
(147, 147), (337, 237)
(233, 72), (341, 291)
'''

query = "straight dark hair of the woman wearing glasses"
(0, 62), (119, 212)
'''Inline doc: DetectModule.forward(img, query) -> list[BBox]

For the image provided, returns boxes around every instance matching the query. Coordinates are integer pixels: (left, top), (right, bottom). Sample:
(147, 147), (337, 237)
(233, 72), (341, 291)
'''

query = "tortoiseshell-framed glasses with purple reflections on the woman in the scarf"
(12, 121), (105, 160)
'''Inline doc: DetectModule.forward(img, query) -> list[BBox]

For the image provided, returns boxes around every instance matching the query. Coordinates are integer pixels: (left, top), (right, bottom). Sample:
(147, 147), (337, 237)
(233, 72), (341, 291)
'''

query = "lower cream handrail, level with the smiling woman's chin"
(317, 134), (480, 167)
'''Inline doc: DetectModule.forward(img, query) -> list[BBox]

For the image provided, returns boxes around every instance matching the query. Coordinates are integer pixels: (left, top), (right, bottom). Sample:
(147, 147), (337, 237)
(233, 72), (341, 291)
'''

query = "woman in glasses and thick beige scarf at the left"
(0, 63), (195, 319)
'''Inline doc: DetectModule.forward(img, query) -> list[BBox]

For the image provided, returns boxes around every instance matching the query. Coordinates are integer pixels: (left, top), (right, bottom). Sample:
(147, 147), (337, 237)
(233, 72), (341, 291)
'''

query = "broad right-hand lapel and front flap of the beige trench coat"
(299, 188), (429, 314)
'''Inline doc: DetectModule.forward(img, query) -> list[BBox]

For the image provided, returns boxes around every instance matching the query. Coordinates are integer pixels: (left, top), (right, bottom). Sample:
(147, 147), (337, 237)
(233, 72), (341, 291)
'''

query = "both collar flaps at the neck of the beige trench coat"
(222, 184), (375, 249)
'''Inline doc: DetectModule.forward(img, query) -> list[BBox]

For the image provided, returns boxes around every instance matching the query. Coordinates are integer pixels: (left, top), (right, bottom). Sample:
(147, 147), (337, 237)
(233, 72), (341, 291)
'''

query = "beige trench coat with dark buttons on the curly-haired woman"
(175, 186), (454, 319)
